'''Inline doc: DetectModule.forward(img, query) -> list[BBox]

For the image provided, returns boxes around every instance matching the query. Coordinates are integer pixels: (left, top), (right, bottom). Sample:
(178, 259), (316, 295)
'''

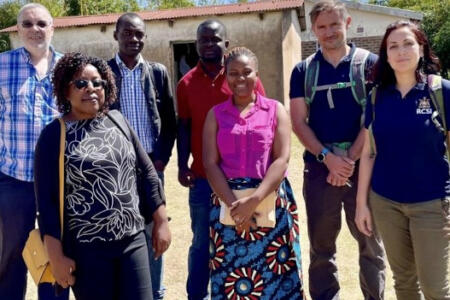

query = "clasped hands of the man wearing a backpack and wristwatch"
(325, 153), (355, 187)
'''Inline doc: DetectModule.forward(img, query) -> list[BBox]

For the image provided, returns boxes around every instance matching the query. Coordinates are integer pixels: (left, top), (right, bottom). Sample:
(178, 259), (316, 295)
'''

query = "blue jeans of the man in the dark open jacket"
(145, 172), (166, 300)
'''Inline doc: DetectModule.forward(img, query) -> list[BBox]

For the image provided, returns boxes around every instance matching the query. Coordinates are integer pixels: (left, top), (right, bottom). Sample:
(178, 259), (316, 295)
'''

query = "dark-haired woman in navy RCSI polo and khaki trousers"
(356, 21), (450, 300)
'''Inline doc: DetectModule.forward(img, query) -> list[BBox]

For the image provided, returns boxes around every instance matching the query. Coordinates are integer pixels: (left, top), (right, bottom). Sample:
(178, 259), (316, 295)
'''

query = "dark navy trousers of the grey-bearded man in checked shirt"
(0, 172), (69, 300)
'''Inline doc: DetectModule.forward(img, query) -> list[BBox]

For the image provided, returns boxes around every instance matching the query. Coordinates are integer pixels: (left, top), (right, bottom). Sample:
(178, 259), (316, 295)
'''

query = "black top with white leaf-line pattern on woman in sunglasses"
(65, 117), (144, 243)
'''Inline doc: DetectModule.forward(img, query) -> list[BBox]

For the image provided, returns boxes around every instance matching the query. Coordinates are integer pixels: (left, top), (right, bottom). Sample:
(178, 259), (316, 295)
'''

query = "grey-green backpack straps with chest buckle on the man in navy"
(305, 48), (370, 126)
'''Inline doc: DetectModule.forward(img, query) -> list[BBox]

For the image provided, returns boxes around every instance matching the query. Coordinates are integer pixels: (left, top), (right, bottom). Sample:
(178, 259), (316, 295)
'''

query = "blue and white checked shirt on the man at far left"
(0, 47), (62, 181)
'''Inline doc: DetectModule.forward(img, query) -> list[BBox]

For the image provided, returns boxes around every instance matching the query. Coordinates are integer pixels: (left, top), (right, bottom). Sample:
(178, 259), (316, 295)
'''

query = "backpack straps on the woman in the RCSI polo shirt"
(369, 75), (450, 160)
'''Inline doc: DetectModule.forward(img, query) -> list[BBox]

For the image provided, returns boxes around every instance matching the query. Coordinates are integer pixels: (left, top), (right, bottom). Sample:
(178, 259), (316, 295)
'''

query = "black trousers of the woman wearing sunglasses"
(69, 231), (153, 300)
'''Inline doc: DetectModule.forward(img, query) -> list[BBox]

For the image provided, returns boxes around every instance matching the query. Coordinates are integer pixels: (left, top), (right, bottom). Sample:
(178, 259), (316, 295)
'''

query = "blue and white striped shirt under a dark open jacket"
(116, 54), (153, 153)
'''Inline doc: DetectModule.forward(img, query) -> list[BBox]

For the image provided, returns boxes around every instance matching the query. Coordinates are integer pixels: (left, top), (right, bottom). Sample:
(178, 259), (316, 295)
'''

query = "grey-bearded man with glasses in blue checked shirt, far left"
(0, 3), (68, 300)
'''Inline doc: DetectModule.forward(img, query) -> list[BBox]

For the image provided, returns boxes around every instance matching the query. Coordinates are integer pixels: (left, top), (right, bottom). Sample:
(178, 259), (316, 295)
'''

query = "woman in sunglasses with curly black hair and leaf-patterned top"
(35, 53), (170, 300)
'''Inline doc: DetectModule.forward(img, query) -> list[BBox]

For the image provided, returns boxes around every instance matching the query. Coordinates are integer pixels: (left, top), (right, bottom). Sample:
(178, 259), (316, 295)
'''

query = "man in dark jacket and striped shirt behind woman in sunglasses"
(108, 13), (176, 300)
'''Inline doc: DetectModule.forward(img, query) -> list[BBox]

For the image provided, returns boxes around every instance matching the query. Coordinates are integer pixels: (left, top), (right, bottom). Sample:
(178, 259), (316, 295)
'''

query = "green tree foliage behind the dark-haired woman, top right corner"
(374, 0), (450, 78)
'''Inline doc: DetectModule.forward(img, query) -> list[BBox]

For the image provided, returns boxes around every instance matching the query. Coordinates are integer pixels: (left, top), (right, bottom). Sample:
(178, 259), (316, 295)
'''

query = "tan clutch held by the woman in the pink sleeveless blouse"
(219, 188), (277, 228)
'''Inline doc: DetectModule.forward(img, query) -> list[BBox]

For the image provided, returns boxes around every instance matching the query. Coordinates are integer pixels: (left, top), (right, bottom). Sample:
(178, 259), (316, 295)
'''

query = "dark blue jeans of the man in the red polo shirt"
(186, 178), (212, 300)
